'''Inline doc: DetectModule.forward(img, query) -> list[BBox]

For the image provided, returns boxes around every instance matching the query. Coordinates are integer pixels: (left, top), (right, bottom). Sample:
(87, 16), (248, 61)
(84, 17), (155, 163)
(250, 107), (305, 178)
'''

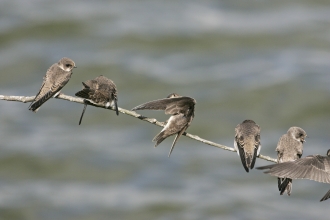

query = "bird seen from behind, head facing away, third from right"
(234, 120), (261, 172)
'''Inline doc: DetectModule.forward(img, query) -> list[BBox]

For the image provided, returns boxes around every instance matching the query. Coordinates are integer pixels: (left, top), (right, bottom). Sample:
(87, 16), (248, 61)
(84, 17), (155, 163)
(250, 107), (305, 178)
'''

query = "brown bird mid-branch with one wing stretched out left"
(132, 93), (196, 156)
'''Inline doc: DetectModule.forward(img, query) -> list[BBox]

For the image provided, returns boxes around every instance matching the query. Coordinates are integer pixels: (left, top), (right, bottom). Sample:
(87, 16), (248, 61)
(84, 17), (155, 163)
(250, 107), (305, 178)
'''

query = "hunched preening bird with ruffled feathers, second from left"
(75, 75), (119, 125)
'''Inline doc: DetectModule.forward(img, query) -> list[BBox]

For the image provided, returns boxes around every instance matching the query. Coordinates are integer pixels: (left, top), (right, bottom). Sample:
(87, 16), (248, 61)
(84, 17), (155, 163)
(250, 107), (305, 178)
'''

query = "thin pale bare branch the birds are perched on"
(0, 93), (277, 163)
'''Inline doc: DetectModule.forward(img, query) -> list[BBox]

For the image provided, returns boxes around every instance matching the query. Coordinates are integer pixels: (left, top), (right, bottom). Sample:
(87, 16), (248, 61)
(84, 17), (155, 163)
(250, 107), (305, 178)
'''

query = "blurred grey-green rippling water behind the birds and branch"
(0, 0), (330, 220)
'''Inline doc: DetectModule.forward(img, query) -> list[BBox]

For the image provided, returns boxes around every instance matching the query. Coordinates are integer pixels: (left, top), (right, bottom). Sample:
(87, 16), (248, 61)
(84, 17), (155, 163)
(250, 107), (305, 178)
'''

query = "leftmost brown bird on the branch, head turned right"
(29, 57), (76, 112)
